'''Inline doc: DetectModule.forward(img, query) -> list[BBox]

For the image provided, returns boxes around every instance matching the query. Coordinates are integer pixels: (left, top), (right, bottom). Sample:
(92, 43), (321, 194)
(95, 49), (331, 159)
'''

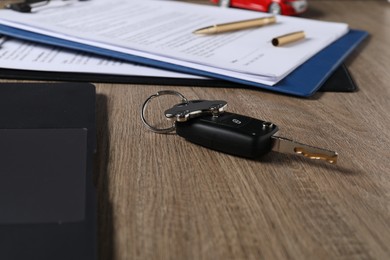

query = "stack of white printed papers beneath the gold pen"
(0, 0), (348, 85)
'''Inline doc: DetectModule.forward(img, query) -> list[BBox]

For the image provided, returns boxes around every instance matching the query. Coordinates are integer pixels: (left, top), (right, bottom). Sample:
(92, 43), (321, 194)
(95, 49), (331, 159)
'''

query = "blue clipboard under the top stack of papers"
(0, 25), (368, 97)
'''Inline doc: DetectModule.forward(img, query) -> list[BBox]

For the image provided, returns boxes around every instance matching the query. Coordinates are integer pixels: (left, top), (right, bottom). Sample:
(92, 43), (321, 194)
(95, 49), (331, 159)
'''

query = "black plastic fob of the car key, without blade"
(176, 112), (278, 158)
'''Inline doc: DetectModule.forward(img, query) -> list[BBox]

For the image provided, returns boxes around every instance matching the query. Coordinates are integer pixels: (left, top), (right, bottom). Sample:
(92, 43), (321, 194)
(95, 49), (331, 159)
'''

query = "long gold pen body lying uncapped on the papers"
(193, 16), (276, 34)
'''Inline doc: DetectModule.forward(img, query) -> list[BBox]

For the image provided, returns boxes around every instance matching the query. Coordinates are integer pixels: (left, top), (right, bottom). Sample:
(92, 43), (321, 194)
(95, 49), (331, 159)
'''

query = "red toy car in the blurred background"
(211, 0), (307, 15)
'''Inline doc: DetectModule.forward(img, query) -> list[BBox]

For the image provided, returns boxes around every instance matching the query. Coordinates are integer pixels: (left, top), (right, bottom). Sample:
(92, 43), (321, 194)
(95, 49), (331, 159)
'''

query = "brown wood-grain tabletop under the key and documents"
(0, 0), (390, 260)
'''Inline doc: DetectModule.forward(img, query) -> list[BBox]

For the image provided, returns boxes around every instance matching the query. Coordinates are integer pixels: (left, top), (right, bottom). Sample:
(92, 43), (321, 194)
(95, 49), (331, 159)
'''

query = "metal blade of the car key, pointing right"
(271, 136), (338, 164)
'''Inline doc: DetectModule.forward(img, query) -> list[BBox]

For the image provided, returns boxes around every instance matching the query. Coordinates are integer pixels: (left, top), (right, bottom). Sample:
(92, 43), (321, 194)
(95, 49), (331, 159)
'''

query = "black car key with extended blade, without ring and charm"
(176, 112), (337, 164)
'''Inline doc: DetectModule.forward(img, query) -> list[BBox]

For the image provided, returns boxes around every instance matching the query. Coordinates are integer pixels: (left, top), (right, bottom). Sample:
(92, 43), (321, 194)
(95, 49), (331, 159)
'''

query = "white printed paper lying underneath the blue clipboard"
(0, 37), (204, 79)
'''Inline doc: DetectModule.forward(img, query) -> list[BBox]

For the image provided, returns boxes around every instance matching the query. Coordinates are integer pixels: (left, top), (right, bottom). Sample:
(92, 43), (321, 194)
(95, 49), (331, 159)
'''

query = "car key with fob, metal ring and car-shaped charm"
(141, 90), (338, 164)
